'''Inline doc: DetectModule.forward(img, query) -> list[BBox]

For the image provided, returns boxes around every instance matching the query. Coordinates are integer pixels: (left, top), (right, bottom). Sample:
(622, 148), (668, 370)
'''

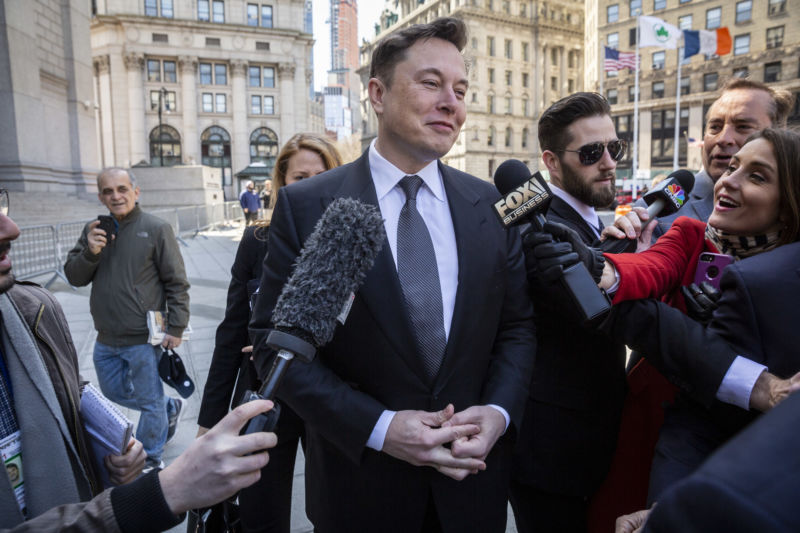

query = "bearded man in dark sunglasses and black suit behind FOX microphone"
(510, 92), (626, 533)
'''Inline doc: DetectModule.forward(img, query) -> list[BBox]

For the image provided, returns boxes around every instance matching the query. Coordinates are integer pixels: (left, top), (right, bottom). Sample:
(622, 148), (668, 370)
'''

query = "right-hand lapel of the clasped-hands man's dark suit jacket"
(435, 162), (484, 389)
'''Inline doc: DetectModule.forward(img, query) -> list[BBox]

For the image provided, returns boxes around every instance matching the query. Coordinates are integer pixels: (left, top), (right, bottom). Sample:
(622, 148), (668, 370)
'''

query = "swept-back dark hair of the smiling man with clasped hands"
(369, 17), (467, 87)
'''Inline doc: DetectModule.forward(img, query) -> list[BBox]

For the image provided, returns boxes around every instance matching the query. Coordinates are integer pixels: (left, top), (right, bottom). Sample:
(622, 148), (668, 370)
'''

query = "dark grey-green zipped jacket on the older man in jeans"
(64, 205), (189, 346)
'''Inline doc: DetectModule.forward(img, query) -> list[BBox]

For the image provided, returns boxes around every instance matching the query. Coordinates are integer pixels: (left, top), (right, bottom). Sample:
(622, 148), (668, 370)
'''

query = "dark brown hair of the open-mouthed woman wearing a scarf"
(745, 128), (800, 245)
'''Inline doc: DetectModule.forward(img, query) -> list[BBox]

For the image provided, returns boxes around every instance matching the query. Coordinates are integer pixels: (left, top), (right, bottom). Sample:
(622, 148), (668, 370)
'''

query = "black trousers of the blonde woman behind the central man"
(239, 403), (305, 533)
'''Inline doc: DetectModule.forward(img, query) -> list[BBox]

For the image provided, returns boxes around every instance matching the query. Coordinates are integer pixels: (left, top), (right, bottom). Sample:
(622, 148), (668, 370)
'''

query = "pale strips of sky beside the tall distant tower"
(313, 0), (383, 91)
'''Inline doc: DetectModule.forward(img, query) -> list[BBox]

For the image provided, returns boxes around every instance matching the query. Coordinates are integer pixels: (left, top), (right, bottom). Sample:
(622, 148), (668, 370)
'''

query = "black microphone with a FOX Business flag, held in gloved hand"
(494, 159), (611, 320)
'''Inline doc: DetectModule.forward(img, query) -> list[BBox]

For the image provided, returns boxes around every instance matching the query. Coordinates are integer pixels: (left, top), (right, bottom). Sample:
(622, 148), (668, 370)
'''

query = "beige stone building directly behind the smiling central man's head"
(359, 0), (584, 180)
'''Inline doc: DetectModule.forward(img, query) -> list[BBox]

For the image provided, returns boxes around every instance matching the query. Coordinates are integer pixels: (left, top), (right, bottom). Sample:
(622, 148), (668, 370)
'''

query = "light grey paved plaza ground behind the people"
(40, 220), (516, 533)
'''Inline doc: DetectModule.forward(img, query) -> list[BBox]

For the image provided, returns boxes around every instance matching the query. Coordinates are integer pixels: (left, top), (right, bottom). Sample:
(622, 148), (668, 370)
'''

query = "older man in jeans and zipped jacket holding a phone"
(64, 168), (189, 469)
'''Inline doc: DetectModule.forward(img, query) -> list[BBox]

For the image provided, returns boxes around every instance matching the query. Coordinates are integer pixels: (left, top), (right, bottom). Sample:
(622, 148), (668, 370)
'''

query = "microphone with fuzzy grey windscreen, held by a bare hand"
(243, 198), (386, 434)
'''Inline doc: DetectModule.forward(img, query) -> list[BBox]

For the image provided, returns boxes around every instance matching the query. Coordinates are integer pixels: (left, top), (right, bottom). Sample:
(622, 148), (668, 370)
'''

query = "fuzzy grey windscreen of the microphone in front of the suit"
(272, 198), (386, 347)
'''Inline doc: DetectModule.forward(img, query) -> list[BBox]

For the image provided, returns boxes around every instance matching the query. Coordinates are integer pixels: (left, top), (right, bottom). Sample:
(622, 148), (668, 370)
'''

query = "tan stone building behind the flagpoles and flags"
(584, 0), (800, 179)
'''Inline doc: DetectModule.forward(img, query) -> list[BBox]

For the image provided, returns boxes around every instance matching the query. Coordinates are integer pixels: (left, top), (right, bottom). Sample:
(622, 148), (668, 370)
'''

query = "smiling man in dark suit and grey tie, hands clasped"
(251, 18), (535, 533)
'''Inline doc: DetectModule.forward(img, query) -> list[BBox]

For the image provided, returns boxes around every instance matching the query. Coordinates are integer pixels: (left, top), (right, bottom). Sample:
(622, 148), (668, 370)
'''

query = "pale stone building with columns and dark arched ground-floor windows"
(91, 0), (313, 197)
